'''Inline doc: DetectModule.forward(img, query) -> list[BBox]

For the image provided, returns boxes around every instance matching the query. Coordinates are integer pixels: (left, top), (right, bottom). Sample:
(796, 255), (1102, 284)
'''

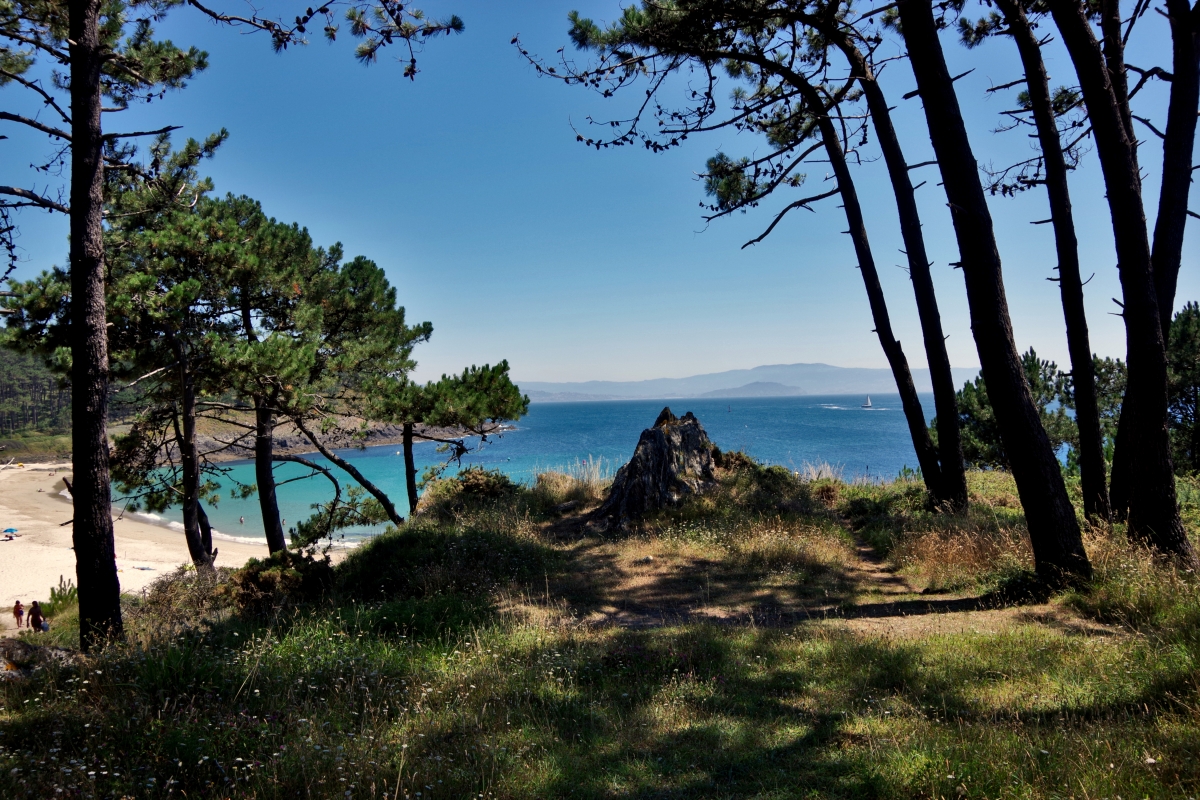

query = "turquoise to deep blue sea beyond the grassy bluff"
(133, 395), (934, 540)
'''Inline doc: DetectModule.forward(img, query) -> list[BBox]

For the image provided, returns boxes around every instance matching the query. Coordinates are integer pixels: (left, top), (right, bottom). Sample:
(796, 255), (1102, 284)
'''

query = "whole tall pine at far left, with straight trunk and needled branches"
(0, 0), (463, 650)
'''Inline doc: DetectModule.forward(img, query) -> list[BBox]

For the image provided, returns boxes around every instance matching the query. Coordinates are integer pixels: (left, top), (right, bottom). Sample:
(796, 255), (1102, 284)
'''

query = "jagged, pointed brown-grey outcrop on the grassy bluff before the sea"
(595, 408), (716, 529)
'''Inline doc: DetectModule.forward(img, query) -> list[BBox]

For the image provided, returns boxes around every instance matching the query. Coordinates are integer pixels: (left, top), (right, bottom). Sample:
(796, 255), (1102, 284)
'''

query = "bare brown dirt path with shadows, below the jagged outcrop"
(528, 523), (1117, 638)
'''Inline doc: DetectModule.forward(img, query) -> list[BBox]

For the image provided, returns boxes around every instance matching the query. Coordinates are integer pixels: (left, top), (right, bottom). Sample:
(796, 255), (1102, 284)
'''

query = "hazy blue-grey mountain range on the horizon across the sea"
(520, 363), (979, 403)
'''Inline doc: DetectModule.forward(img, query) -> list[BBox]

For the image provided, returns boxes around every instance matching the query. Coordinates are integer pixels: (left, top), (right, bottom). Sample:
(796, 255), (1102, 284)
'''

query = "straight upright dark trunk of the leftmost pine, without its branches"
(67, 0), (122, 652)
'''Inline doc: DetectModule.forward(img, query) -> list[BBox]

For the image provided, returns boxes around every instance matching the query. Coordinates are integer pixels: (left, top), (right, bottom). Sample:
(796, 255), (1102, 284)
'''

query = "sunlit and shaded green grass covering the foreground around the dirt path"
(0, 465), (1200, 800)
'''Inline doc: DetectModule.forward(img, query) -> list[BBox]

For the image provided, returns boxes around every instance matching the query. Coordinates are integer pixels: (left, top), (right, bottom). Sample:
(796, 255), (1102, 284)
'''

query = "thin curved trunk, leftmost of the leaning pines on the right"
(787, 72), (950, 504)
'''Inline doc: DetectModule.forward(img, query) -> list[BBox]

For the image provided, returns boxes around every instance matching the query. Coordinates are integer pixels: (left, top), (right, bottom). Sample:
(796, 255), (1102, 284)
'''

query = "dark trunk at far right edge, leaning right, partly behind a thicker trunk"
(1150, 0), (1200, 331)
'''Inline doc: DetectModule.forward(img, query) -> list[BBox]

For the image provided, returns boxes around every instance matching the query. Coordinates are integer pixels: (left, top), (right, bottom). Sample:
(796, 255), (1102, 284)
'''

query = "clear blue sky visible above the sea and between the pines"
(0, 0), (1200, 380)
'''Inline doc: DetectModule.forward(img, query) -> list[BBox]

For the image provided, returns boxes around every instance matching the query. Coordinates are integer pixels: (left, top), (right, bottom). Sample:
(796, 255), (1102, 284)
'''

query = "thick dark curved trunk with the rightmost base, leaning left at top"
(1050, 0), (1196, 565)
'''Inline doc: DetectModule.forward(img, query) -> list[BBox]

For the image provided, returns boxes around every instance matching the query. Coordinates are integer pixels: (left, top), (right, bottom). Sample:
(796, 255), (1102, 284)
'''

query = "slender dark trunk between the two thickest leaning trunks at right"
(997, 0), (1109, 521)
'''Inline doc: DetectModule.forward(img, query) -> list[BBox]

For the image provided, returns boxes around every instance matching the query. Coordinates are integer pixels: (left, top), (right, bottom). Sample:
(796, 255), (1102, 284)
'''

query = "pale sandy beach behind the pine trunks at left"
(0, 464), (266, 634)
